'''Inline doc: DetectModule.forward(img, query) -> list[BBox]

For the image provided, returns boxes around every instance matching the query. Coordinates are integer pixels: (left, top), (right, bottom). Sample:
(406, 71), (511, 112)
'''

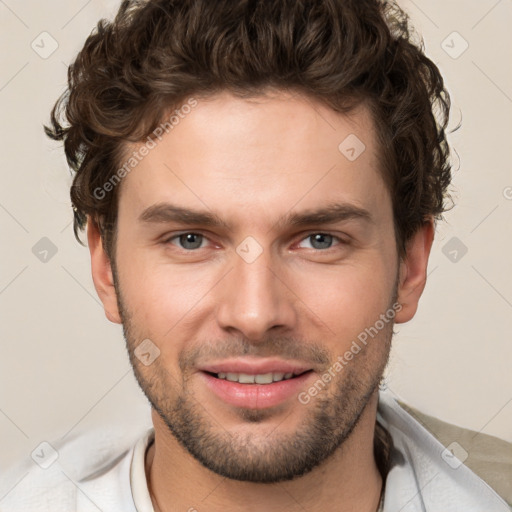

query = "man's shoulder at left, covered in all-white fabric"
(0, 427), (147, 512)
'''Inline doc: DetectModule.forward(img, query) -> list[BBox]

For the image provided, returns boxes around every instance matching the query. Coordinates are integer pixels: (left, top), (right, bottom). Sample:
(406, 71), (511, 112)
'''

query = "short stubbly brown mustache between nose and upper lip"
(178, 335), (333, 372)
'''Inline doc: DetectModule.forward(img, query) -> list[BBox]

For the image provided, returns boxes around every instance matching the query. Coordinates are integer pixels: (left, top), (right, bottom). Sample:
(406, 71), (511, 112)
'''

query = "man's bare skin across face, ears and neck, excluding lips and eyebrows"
(88, 92), (434, 512)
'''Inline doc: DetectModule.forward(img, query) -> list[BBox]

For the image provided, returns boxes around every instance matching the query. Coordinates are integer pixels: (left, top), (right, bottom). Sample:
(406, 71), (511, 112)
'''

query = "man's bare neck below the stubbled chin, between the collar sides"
(146, 392), (383, 512)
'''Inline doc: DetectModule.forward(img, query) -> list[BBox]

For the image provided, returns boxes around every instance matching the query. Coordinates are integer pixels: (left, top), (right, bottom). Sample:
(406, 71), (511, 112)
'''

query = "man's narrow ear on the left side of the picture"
(87, 217), (121, 324)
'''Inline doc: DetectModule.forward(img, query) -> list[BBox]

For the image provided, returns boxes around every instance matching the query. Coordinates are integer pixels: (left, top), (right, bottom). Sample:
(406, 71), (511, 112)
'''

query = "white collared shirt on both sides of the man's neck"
(0, 391), (511, 512)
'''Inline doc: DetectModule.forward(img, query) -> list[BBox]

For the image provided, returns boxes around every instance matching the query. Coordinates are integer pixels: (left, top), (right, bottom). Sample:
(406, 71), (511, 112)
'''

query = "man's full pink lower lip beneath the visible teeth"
(199, 371), (314, 409)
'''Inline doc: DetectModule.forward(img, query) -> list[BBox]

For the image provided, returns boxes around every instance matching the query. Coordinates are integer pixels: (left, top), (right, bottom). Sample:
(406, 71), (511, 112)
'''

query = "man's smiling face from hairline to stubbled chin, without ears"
(104, 93), (399, 482)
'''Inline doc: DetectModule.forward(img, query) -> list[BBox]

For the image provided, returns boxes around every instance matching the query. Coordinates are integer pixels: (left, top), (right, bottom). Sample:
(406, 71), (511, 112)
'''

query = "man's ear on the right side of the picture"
(395, 217), (434, 324)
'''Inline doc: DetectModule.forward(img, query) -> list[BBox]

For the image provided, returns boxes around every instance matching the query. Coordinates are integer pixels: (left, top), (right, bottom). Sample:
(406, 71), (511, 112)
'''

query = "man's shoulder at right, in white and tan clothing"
(377, 389), (512, 512)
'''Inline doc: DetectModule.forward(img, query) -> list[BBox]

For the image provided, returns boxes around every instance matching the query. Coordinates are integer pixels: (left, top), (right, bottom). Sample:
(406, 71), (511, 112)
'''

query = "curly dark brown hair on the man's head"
(45, 0), (451, 257)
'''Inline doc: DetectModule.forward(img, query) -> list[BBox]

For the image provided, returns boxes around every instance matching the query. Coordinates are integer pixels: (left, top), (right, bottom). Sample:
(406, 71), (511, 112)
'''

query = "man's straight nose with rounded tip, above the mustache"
(216, 243), (297, 341)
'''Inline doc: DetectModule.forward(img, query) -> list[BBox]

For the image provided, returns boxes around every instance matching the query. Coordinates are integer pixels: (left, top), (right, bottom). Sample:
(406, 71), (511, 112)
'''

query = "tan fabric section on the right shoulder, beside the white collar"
(397, 400), (512, 505)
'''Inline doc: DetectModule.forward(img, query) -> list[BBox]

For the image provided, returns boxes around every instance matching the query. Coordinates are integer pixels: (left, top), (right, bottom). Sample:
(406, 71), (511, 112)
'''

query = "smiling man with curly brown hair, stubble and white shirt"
(0, 0), (508, 512)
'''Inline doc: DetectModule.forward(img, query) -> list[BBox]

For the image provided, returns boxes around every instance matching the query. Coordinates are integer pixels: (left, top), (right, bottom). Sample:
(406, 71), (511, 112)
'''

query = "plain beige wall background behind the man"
(0, 0), (512, 476)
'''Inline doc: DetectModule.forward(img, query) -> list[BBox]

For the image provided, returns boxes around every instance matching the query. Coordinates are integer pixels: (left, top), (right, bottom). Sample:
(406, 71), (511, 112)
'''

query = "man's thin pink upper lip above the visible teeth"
(199, 359), (312, 375)
